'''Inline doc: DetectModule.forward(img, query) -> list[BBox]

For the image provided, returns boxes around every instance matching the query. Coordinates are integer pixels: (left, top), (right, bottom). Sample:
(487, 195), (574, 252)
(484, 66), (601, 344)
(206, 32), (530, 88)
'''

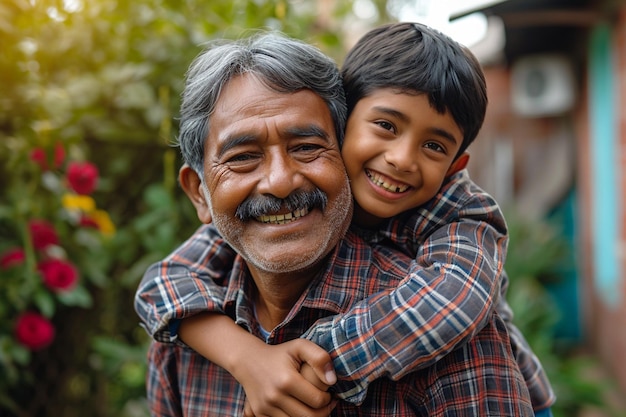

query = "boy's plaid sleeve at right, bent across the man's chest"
(305, 211), (507, 403)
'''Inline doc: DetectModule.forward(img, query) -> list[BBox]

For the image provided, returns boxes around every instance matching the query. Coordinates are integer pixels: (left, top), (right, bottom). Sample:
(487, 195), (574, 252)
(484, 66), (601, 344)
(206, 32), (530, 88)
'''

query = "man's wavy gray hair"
(178, 32), (346, 174)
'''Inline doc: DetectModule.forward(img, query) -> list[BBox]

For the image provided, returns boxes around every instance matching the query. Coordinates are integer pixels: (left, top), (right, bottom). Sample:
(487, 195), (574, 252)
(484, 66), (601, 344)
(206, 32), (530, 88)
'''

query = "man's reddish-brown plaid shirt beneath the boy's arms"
(147, 232), (533, 417)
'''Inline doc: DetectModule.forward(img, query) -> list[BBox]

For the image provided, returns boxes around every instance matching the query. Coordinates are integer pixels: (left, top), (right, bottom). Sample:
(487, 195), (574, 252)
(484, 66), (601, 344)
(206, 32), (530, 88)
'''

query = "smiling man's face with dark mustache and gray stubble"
(203, 75), (352, 273)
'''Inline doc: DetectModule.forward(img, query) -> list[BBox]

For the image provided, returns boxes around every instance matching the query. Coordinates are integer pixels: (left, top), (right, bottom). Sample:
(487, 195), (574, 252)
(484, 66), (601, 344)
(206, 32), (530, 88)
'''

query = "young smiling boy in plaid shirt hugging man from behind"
(136, 23), (554, 415)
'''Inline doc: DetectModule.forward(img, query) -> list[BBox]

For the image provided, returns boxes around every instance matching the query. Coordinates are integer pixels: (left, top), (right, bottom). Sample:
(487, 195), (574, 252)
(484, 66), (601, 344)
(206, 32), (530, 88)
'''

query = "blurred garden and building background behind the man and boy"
(0, 0), (626, 417)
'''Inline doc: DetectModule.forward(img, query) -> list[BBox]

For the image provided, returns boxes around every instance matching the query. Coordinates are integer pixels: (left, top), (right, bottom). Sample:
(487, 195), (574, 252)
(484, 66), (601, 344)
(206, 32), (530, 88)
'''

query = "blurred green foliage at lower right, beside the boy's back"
(506, 213), (618, 417)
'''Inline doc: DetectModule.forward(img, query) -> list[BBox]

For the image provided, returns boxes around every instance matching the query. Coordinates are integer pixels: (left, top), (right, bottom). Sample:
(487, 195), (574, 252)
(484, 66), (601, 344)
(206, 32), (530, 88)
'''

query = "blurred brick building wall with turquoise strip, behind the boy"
(469, 0), (626, 392)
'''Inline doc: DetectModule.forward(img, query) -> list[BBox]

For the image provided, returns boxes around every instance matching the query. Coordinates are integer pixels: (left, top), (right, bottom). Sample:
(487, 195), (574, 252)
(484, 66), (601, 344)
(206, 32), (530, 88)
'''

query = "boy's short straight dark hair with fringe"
(341, 22), (487, 156)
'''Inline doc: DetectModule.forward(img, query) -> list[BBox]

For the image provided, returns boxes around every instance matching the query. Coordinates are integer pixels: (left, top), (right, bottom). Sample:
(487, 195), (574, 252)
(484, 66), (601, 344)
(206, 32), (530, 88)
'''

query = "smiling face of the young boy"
(341, 88), (463, 223)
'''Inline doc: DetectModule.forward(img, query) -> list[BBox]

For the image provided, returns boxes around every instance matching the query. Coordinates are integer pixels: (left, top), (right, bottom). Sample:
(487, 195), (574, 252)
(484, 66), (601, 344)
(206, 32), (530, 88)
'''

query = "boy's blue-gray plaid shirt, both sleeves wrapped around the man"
(136, 171), (554, 409)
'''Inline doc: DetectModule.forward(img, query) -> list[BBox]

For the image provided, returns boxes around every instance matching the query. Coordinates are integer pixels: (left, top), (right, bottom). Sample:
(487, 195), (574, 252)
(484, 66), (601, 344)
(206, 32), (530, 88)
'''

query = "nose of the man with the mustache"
(258, 150), (304, 198)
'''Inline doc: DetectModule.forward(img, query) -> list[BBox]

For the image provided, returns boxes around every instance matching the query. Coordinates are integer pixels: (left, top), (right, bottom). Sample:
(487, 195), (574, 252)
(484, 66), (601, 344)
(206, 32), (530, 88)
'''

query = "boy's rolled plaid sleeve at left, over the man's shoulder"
(135, 225), (236, 343)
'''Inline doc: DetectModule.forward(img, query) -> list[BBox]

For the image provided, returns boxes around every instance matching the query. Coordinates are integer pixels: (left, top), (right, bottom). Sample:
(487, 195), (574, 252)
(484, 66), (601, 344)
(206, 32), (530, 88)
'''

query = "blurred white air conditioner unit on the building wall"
(511, 54), (575, 117)
